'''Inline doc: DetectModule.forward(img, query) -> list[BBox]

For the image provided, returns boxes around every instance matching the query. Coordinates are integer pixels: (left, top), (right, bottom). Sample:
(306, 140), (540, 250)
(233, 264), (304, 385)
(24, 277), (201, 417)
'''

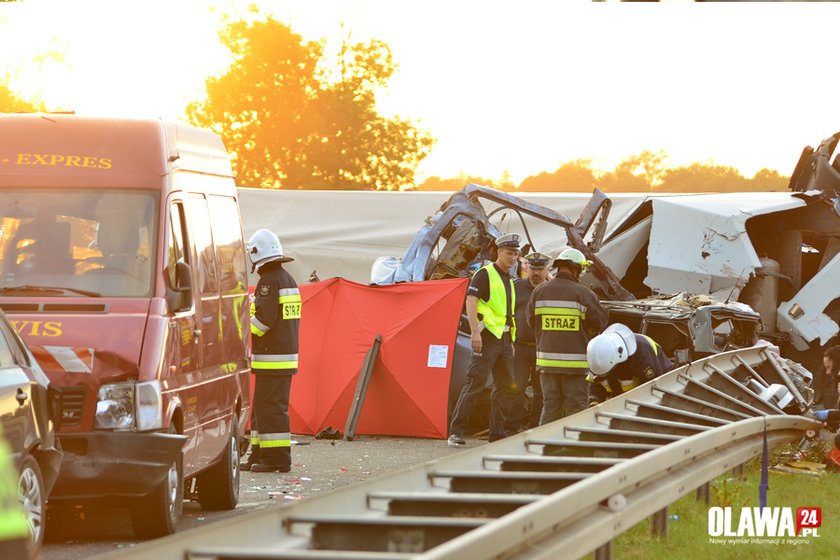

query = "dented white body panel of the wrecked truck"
(645, 193), (806, 299)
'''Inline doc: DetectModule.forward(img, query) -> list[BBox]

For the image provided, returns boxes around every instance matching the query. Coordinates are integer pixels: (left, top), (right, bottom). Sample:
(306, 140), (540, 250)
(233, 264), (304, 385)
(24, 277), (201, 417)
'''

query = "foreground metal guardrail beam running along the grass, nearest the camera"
(415, 416), (815, 560)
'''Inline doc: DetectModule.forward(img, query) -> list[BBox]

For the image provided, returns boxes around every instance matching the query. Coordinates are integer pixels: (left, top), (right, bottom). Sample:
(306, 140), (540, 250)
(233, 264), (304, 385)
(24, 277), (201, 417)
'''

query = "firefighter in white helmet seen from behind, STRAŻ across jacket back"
(526, 247), (607, 425)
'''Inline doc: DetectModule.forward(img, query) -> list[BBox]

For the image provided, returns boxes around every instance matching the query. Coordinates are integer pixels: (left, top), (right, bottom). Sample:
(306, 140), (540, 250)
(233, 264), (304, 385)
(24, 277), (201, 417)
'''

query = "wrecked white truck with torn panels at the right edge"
(598, 133), (840, 403)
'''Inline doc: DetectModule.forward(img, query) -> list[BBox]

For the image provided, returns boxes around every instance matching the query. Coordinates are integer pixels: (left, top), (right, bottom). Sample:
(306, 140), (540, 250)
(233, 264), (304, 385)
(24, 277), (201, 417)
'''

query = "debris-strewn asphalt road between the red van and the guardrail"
(41, 436), (485, 560)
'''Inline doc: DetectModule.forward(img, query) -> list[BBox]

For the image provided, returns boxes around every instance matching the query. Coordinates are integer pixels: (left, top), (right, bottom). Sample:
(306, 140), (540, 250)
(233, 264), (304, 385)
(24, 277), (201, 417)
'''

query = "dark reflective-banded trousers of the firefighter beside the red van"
(251, 370), (292, 467)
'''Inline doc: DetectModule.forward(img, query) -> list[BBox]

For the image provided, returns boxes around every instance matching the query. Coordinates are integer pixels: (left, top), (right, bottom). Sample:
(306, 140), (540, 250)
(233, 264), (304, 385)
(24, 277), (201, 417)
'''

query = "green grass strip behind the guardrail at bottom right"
(613, 446), (840, 560)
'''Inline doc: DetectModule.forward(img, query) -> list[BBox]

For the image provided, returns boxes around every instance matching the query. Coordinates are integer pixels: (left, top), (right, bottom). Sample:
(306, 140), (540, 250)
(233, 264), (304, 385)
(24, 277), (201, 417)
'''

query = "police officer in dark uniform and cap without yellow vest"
(513, 253), (551, 428)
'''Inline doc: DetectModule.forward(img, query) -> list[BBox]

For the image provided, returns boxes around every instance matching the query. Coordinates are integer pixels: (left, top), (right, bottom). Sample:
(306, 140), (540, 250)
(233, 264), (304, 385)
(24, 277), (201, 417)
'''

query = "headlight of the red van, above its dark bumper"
(95, 381), (163, 431)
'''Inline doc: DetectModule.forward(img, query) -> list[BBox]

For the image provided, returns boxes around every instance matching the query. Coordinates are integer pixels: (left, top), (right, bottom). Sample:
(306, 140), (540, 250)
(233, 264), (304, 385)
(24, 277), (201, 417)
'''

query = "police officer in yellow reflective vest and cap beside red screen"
(448, 233), (522, 447)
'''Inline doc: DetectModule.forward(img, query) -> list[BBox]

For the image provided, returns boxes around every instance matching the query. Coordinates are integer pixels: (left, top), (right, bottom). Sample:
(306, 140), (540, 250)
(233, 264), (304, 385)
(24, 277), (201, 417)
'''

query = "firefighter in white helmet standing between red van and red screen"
(242, 229), (301, 472)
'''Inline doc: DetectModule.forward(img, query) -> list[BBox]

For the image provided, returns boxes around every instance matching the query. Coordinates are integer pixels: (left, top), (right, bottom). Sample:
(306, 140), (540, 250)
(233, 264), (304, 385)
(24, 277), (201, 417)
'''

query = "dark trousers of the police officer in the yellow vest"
(449, 329), (524, 441)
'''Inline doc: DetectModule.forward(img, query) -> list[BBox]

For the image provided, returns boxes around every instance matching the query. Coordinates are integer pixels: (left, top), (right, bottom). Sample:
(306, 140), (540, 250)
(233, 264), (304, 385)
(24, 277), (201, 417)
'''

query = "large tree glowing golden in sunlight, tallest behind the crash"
(187, 17), (433, 190)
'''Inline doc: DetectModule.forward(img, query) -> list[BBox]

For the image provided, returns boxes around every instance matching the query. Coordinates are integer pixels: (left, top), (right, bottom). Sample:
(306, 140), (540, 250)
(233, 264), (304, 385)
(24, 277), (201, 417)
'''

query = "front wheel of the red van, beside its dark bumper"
(131, 429), (184, 539)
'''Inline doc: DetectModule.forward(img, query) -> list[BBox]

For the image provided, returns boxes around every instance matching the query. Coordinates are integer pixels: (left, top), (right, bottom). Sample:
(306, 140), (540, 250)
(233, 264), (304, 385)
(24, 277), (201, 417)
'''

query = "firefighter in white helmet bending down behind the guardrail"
(586, 323), (674, 405)
